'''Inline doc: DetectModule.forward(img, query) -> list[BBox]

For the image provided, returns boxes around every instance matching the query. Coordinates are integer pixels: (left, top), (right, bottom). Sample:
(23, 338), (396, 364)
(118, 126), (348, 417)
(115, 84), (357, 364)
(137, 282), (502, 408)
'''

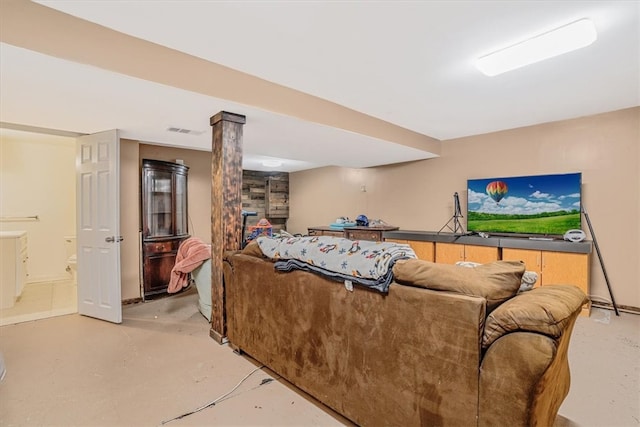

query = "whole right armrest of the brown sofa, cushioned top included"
(478, 285), (586, 426)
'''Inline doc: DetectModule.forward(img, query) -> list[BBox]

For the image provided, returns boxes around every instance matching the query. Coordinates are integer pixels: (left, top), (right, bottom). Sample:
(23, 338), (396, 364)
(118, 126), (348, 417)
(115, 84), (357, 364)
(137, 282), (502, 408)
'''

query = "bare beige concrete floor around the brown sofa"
(0, 290), (640, 427)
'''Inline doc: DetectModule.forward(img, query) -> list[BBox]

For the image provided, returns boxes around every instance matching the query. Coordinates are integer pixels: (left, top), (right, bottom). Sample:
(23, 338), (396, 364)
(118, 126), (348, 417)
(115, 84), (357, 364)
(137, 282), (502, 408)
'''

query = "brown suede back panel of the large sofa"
(224, 253), (486, 426)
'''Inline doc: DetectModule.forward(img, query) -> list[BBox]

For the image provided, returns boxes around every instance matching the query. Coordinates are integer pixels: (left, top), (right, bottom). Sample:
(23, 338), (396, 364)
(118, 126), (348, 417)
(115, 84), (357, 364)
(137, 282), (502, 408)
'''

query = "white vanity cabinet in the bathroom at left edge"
(0, 231), (28, 308)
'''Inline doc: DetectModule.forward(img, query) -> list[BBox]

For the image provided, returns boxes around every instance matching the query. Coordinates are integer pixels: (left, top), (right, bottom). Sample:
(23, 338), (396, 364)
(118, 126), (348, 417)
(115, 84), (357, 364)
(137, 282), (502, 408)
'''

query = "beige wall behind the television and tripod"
(288, 108), (640, 307)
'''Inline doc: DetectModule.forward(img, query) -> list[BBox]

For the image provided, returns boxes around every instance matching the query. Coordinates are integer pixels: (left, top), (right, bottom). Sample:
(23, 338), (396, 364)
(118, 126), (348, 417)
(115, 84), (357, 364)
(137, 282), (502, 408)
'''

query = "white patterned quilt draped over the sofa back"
(257, 236), (417, 293)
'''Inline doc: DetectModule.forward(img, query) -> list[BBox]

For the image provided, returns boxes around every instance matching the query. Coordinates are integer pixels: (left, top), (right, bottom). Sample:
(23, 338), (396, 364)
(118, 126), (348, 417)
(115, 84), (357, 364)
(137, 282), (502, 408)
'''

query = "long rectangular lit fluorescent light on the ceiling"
(476, 19), (598, 76)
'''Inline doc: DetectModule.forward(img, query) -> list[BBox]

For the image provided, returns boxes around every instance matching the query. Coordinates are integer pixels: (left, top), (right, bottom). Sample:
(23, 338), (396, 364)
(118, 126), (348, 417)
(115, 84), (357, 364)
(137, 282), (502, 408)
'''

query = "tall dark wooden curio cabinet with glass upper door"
(141, 159), (189, 297)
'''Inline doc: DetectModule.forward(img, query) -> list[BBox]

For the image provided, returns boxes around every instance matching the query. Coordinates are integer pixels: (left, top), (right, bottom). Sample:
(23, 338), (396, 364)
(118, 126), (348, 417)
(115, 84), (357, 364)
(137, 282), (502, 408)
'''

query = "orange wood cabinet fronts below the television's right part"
(502, 248), (591, 316)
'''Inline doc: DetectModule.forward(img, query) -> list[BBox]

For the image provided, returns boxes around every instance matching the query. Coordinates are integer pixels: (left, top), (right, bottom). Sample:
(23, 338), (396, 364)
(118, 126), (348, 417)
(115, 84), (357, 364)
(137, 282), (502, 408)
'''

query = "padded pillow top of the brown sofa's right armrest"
(482, 285), (587, 348)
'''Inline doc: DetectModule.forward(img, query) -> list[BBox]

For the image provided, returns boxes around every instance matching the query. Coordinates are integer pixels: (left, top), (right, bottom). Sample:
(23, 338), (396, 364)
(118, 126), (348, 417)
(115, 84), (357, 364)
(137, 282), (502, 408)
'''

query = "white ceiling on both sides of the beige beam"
(0, 0), (640, 171)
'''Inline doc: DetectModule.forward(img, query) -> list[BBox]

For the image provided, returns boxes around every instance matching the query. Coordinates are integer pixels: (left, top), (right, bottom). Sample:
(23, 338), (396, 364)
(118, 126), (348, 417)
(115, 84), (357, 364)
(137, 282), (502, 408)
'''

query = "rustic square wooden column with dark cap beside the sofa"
(209, 111), (246, 344)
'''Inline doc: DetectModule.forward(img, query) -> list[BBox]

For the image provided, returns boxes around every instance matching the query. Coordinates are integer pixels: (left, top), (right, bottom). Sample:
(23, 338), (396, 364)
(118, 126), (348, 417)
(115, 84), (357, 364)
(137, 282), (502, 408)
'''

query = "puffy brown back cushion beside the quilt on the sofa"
(393, 259), (524, 312)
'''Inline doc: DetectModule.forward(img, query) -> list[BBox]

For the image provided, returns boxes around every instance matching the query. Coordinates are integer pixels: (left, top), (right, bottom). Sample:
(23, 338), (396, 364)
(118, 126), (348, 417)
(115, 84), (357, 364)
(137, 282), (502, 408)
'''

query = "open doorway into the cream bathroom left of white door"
(0, 128), (78, 325)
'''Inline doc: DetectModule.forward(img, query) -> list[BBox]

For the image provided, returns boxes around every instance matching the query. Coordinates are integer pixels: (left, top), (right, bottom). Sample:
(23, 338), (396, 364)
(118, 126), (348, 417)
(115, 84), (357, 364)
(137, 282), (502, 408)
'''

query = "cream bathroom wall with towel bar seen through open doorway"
(0, 129), (76, 282)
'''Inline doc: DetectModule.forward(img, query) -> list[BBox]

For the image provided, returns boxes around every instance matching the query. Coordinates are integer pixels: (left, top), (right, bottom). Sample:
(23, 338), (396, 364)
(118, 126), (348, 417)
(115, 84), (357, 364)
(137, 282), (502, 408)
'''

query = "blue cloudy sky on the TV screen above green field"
(467, 173), (582, 215)
